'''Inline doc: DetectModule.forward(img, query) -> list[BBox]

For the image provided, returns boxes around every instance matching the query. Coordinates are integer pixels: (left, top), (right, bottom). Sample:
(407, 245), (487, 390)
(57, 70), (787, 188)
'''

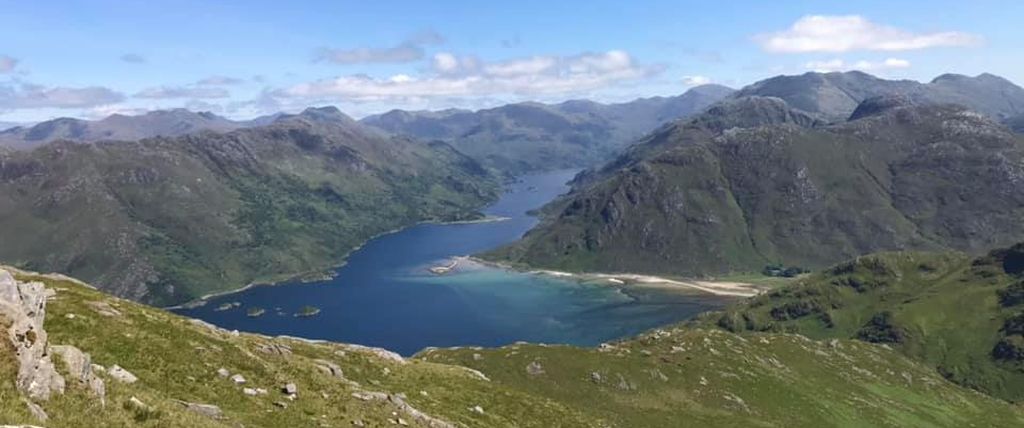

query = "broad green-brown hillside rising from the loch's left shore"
(0, 109), (498, 304)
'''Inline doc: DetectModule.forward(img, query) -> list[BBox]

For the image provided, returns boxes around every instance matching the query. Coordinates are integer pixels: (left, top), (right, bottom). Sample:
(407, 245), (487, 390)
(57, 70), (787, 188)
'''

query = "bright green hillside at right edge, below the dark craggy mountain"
(703, 245), (1024, 402)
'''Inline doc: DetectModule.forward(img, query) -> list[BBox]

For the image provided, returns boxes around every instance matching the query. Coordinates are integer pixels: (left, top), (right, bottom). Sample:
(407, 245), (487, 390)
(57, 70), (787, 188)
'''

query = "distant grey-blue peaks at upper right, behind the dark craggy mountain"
(733, 72), (1024, 122)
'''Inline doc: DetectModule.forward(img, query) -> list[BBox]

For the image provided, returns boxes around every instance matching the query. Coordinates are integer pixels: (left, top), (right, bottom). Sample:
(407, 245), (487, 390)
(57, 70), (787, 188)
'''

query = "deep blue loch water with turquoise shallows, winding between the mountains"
(178, 171), (725, 355)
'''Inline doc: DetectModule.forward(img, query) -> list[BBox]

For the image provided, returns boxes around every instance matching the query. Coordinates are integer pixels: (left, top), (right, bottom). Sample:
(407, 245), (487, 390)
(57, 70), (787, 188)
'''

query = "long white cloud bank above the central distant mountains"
(276, 50), (663, 102)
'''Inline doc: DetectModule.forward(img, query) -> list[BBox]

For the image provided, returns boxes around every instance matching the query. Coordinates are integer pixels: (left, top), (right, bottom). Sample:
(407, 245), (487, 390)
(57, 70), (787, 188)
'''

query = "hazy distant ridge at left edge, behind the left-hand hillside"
(0, 109), (250, 149)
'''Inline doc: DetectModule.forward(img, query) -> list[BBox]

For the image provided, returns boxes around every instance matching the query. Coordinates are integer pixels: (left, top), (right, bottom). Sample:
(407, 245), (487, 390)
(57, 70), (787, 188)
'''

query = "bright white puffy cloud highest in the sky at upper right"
(755, 15), (982, 53)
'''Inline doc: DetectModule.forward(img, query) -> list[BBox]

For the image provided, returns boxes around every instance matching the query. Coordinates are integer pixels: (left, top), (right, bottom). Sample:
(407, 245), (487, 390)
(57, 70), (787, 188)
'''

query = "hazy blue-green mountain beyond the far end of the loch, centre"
(361, 85), (732, 174)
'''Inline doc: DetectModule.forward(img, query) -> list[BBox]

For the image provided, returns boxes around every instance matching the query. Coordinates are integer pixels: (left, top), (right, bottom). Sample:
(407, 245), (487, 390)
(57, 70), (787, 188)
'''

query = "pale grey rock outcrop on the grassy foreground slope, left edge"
(0, 269), (65, 400)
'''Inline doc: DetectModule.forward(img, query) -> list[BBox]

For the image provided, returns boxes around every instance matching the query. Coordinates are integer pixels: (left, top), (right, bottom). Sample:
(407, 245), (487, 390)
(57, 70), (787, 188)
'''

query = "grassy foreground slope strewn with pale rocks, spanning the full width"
(0, 271), (1024, 428)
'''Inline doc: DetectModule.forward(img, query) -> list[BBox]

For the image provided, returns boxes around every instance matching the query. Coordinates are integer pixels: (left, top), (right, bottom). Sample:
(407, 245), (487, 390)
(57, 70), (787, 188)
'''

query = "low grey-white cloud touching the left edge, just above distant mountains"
(0, 83), (125, 110)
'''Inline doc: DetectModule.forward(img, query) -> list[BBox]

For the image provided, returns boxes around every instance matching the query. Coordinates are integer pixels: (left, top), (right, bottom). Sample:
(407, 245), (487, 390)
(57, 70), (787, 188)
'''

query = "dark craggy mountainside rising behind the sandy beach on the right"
(486, 97), (1024, 275)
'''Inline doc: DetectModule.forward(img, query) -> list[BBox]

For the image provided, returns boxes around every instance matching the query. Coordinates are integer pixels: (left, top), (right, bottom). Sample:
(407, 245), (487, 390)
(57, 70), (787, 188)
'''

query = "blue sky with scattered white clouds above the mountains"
(0, 0), (1024, 123)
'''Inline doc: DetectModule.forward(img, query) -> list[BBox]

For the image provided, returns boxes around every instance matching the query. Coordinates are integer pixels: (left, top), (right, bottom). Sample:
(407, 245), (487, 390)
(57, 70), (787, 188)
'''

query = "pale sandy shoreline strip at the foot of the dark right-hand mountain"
(466, 256), (768, 298)
